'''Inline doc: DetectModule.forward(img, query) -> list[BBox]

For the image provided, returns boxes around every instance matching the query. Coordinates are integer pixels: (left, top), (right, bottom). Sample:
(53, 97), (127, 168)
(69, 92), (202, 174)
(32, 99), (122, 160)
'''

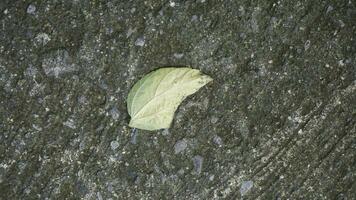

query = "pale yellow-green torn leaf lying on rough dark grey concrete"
(127, 67), (212, 130)
